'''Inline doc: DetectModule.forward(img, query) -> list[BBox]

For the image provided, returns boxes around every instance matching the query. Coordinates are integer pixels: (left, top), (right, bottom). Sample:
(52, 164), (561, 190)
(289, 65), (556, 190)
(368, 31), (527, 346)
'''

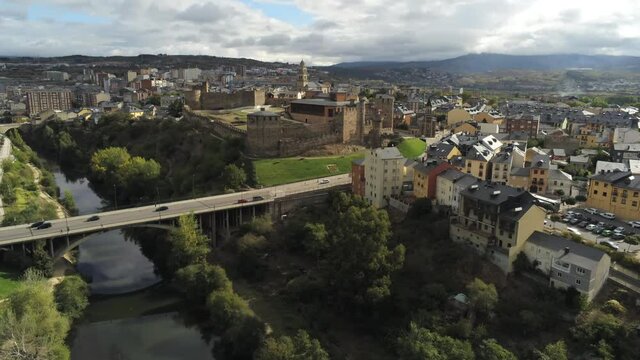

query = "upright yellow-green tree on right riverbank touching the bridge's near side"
(169, 214), (211, 269)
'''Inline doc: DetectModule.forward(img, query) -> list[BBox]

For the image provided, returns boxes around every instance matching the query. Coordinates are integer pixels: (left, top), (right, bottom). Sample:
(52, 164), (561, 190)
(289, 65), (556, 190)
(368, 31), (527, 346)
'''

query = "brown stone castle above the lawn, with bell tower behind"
(247, 61), (395, 157)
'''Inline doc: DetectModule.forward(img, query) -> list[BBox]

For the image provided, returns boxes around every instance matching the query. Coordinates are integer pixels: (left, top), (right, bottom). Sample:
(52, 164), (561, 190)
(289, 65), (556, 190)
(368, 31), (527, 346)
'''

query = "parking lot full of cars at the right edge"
(547, 208), (640, 252)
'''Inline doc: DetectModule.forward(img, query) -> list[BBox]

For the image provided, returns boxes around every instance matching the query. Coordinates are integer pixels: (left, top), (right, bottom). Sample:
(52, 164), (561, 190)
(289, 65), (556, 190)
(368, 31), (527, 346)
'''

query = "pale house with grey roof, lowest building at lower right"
(524, 231), (611, 301)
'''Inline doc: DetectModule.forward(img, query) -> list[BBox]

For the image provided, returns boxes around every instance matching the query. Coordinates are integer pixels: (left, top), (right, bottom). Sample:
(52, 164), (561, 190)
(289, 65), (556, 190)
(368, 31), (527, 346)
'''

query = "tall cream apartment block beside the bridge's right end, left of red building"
(364, 147), (406, 208)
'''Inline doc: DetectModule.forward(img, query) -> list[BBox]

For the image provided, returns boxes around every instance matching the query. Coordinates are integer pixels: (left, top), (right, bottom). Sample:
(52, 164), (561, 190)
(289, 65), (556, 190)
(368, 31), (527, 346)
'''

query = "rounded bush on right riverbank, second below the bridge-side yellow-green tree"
(207, 290), (254, 329)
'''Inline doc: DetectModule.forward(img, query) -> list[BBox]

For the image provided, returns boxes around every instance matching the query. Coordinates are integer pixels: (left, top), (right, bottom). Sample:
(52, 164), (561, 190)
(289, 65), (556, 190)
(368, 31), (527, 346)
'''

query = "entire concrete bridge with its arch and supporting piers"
(0, 175), (351, 256)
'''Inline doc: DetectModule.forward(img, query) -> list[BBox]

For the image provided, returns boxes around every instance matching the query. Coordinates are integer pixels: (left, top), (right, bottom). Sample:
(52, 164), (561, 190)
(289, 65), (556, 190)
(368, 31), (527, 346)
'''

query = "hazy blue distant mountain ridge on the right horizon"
(328, 54), (640, 74)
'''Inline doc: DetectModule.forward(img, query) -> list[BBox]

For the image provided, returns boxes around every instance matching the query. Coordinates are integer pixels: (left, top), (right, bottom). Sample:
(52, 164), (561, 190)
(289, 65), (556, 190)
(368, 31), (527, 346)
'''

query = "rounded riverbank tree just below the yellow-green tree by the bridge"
(175, 262), (232, 304)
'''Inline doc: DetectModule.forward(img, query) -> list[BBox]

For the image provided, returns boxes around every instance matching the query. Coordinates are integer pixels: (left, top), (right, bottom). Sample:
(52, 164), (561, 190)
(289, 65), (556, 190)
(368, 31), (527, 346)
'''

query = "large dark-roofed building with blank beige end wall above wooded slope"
(450, 182), (545, 273)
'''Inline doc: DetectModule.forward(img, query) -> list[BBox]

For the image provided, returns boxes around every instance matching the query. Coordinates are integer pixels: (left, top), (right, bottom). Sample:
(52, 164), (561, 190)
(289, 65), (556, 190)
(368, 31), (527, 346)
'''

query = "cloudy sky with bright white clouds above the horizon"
(0, 0), (640, 65)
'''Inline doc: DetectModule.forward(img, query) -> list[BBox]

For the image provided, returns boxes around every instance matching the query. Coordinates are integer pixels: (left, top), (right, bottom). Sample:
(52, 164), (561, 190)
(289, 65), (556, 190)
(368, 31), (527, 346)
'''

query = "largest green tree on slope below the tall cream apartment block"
(325, 194), (405, 304)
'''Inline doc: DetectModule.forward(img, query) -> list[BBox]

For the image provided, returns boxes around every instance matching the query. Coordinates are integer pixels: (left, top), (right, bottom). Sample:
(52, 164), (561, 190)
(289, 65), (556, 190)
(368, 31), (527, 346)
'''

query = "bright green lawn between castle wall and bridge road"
(253, 153), (364, 186)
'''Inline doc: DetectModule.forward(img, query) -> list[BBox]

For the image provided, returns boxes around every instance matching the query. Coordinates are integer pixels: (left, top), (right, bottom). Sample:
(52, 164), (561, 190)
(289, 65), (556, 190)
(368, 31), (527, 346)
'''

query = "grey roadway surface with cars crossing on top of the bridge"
(0, 174), (351, 246)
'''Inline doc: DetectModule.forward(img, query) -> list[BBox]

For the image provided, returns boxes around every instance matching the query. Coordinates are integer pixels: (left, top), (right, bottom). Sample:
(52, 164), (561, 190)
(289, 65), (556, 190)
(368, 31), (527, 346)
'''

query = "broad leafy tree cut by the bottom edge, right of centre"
(397, 323), (475, 360)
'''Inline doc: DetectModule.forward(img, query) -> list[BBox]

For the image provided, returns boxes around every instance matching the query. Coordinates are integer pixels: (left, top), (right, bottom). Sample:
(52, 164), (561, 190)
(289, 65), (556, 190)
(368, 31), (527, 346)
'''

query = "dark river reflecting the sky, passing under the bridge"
(53, 169), (213, 360)
